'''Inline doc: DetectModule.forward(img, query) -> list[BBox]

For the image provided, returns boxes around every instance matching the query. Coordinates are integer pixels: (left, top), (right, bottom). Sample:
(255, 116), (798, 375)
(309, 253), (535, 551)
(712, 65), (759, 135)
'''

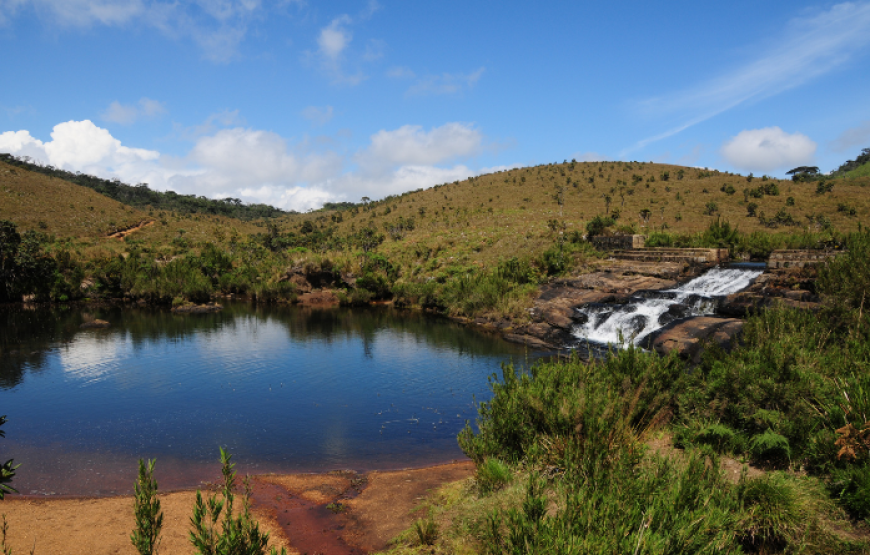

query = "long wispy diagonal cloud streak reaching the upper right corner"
(623, 1), (870, 155)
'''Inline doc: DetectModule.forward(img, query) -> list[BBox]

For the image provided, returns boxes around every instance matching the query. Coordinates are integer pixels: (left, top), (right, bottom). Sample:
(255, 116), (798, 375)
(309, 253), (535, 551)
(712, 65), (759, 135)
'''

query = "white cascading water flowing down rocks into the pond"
(573, 267), (762, 350)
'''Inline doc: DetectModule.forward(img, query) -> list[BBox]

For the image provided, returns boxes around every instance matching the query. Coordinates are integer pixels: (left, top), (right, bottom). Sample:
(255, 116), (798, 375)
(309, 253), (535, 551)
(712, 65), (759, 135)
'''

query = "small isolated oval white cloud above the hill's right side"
(721, 127), (816, 172)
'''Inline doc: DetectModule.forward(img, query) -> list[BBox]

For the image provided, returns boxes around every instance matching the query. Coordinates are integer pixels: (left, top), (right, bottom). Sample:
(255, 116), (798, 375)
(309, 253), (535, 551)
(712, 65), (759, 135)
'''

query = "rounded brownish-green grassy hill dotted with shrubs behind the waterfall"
(277, 162), (870, 269)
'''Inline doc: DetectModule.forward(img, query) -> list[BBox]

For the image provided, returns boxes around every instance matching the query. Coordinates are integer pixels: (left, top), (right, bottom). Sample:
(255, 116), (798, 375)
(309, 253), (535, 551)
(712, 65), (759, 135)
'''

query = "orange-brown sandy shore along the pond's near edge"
(0, 461), (474, 555)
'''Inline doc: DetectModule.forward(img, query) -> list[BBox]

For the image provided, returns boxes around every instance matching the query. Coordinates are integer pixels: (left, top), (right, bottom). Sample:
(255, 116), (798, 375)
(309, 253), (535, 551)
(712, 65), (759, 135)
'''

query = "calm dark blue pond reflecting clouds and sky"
(0, 303), (540, 495)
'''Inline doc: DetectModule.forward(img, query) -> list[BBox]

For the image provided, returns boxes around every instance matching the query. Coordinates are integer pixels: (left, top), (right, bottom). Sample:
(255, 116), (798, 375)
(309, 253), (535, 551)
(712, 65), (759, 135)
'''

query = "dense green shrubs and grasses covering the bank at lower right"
(384, 228), (870, 554)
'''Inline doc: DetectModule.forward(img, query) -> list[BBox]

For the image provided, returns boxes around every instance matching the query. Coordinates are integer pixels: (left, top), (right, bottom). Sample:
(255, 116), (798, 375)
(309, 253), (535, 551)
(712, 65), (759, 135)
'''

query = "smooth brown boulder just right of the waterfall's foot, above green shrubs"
(643, 316), (744, 364)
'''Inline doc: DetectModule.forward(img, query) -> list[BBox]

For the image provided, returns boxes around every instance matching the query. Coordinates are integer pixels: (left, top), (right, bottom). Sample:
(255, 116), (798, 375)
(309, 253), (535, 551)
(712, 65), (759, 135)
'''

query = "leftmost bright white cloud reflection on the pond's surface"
(58, 333), (132, 383)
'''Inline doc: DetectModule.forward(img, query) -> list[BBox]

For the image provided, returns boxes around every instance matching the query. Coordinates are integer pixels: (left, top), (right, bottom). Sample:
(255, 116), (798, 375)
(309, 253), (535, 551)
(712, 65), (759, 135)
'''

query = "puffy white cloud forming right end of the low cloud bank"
(357, 123), (483, 172)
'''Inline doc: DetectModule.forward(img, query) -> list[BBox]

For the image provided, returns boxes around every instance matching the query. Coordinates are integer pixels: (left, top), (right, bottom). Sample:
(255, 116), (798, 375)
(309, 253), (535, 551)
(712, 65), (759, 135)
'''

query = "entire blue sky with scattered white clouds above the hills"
(0, 0), (870, 210)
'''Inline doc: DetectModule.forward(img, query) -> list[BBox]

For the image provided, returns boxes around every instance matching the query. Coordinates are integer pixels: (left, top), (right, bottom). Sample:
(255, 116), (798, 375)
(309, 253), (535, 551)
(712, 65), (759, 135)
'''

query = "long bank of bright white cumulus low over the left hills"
(0, 118), (498, 211)
